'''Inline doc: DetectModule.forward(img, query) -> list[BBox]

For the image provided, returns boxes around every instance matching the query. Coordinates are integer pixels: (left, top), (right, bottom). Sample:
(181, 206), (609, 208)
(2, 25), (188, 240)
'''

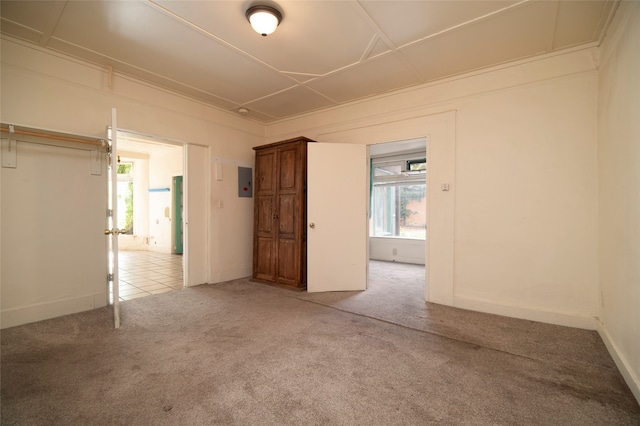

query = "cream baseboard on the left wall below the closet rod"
(0, 292), (107, 329)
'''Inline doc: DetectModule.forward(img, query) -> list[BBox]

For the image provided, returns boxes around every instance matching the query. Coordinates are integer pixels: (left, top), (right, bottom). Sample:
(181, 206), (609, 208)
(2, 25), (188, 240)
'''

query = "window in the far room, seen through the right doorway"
(369, 151), (427, 239)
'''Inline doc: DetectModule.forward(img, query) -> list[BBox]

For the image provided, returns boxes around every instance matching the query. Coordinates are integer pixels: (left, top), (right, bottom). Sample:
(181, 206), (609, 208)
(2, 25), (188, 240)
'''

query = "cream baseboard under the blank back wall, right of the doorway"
(452, 297), (597, 330)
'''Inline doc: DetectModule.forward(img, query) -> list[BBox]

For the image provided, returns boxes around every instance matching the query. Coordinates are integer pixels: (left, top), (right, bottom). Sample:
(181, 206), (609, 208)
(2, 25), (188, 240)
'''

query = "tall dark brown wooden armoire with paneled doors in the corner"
(253, 136), (313, 290)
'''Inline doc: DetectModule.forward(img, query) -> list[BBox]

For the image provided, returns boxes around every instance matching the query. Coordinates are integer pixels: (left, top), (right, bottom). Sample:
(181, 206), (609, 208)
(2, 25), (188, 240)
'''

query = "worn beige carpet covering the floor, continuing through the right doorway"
(1, 262), (640, 425)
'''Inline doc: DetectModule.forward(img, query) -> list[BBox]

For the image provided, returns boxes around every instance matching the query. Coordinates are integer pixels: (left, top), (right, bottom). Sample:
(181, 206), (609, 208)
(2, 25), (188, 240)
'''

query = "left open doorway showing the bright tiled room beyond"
(118, 131), (185, 301)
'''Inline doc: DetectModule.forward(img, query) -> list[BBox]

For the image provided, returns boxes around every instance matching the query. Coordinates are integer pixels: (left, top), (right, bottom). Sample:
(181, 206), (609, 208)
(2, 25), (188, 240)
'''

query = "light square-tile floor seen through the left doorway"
(118, 250), (183, 301)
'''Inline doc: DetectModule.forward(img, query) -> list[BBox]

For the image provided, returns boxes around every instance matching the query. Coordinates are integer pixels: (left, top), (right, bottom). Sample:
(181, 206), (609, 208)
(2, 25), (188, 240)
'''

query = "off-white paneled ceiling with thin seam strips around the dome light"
(0, 0), (619, 123)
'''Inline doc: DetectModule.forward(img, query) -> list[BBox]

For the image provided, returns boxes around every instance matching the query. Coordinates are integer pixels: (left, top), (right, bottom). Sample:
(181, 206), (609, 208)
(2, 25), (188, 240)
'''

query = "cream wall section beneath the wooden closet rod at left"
(0, 140), (107, 327)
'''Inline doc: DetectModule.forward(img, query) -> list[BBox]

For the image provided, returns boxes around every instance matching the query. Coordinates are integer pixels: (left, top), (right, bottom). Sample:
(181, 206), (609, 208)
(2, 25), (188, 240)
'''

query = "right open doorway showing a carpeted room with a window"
(367, 138), (427, 298)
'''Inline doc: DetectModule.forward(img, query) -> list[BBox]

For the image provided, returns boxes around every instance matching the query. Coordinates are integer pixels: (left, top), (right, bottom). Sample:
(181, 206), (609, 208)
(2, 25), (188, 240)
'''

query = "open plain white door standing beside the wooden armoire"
(307, 143), (369, 292)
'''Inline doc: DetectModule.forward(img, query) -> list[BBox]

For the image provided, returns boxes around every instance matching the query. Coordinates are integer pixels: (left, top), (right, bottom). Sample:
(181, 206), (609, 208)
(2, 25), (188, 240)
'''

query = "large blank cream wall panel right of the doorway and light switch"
(455, 72), (598, 327)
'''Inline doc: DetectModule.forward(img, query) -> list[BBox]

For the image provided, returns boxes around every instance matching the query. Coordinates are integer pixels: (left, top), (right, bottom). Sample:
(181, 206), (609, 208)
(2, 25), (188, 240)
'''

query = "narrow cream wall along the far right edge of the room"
(598, 2), (640, 401)
